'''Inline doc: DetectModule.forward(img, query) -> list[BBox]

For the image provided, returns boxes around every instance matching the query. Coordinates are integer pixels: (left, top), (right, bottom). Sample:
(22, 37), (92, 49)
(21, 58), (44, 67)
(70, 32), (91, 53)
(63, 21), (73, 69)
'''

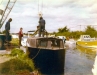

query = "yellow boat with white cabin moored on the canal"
(76, 35), (97, 48)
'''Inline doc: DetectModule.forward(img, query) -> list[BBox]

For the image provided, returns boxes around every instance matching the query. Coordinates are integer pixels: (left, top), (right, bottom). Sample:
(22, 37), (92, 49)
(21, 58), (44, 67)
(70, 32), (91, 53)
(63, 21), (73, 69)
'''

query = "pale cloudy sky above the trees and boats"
(0, 0), (97, 33)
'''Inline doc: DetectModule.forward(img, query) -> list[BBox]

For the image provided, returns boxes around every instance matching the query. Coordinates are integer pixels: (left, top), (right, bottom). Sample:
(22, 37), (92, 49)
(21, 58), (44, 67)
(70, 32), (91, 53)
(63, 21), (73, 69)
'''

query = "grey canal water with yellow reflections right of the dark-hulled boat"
(64, 44), (97, 75)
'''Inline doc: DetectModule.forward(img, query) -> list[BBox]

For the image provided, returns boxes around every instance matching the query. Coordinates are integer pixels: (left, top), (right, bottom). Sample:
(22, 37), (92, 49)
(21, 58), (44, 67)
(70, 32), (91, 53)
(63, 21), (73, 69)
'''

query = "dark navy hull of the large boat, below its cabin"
(28, 47), (65, 75)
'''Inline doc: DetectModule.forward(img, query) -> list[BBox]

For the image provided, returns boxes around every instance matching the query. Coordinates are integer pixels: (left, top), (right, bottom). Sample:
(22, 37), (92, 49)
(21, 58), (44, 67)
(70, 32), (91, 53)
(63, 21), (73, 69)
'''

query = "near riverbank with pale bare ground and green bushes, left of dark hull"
(0, 48), (38, 75)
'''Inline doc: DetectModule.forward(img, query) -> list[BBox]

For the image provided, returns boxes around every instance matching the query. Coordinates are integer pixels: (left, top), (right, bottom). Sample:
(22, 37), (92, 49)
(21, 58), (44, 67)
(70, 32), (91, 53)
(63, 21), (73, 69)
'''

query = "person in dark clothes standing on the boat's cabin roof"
(39, 17), (45, 37)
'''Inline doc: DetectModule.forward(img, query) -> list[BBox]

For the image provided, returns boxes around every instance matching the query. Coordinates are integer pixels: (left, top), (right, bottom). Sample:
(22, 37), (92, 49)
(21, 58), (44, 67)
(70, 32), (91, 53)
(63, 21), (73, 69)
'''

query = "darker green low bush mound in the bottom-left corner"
(0, 58), (34, 75)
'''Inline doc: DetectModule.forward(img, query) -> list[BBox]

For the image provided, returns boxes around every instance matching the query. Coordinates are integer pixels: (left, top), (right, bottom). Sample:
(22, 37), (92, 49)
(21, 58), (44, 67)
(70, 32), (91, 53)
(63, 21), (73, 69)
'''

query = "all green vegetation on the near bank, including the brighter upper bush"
(0, 48), (35, 75)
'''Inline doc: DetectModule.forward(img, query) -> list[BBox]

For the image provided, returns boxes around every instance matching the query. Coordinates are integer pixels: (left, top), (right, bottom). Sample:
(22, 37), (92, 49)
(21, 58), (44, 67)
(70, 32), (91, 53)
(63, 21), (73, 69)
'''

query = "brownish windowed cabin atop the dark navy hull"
(27, 37), (64, 50)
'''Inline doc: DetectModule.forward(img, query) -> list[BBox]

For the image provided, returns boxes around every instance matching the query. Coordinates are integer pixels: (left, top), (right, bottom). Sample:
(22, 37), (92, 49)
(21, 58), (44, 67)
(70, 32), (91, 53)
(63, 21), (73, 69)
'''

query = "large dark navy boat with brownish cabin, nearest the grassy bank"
(27, 37), (65, 75)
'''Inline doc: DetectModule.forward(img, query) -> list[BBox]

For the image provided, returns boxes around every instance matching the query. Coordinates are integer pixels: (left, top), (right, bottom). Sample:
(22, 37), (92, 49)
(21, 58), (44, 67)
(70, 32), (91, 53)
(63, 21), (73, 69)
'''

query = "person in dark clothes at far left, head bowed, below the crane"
(5, 18), (12, 43)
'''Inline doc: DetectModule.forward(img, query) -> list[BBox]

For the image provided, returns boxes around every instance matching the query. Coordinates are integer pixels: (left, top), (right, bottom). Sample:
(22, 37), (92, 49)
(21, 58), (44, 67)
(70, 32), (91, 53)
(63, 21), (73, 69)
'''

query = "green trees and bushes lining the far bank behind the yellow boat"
(54, 26), (97, 39)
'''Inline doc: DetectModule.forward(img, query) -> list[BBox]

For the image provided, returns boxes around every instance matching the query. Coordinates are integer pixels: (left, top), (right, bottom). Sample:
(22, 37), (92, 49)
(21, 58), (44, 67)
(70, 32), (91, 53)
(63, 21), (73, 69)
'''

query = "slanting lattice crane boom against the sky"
(0, 0), (16, 28)
